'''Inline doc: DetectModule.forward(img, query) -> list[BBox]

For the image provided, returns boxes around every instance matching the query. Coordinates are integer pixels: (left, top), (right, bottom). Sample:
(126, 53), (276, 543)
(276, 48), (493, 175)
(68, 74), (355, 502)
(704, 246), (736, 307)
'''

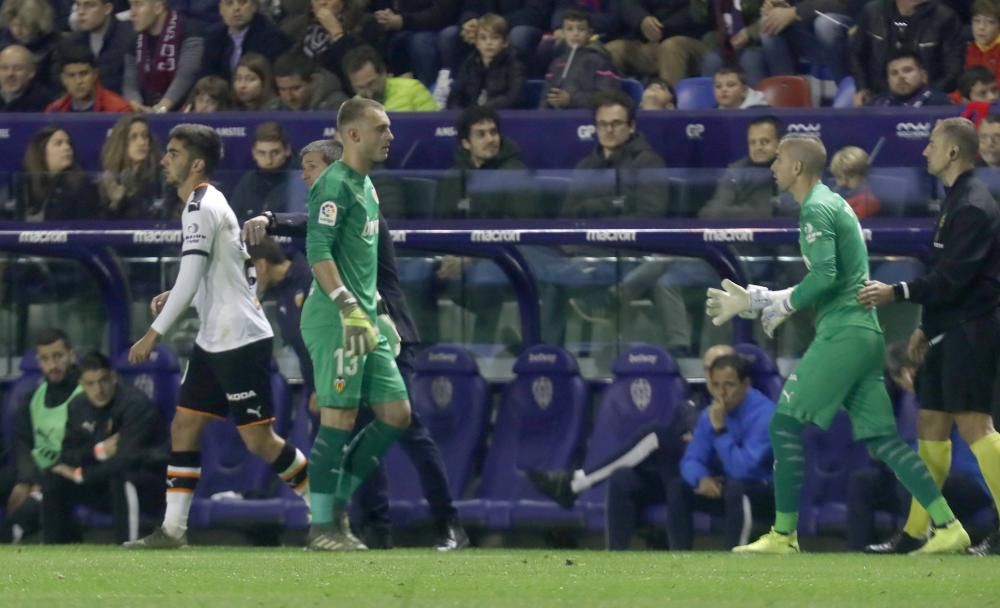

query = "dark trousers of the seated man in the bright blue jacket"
(667, 477), (774, 551)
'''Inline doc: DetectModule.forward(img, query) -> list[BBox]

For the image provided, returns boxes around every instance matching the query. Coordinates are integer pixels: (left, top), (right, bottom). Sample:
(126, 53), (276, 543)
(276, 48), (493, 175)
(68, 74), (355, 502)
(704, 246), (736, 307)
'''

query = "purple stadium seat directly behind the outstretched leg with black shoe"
(576, 344), (687, 530)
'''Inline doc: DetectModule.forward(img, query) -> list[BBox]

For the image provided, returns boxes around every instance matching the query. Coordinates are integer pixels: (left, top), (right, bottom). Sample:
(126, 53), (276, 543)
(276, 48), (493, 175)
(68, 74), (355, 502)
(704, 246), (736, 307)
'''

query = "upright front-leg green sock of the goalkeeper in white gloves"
(769, 414), (806, 534)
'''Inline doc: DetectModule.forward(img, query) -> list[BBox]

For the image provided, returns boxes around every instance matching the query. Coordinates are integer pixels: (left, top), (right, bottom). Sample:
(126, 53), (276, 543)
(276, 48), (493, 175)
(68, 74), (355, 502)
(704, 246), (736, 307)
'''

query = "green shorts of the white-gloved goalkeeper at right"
(777, 327), (897, 440)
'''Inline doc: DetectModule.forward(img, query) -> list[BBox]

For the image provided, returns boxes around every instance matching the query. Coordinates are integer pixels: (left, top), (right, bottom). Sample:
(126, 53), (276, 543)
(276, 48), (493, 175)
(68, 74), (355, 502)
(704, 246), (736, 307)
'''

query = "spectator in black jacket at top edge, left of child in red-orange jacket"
(850, 0), (964, 107)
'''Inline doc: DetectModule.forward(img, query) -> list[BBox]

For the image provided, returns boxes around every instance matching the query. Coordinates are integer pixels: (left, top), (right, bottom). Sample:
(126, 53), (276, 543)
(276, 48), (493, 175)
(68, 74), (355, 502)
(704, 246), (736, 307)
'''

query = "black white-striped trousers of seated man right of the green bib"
(42, 469), (164, 544)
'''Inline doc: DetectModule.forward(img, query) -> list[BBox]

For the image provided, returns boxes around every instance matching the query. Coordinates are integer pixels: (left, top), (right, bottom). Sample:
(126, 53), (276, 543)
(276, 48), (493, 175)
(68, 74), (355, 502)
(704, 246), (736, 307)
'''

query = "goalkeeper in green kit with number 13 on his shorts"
(301, 98), (410, 551)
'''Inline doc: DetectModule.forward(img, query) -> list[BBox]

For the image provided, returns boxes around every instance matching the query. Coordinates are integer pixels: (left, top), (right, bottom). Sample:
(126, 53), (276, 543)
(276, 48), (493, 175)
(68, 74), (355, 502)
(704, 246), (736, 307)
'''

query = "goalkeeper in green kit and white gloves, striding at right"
(706, 137), (969, 553)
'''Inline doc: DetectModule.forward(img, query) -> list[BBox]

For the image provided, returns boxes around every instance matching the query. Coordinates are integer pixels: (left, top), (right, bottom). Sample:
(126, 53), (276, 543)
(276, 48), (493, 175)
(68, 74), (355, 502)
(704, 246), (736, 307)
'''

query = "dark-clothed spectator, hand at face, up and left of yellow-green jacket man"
(282, 0), (384, 93)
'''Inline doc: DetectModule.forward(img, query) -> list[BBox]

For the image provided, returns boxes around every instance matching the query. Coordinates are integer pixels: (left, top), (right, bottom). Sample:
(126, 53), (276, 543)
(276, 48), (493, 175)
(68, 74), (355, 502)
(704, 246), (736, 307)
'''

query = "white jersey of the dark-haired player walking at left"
(174, 184), (274, 353)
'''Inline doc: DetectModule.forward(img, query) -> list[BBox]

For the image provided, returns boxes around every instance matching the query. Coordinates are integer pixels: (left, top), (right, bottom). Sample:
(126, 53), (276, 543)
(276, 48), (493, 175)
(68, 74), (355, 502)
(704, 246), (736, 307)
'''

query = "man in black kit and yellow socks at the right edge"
(858, 118), (1000, 555)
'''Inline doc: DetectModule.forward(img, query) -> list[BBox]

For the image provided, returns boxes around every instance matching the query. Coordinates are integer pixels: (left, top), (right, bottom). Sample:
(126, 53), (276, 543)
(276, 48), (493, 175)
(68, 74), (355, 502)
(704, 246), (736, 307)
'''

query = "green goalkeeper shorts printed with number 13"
(302, 325), (408, 409)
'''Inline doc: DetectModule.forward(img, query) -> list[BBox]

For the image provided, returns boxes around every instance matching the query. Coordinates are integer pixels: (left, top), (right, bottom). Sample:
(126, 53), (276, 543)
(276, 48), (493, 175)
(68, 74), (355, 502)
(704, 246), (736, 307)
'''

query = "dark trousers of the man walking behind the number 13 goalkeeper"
(354, 344), (458, 528)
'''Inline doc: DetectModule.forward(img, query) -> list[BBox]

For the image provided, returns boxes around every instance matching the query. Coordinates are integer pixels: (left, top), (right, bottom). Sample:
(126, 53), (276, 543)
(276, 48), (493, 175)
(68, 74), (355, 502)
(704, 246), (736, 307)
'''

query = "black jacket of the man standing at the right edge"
(897, 170), (1000, 338)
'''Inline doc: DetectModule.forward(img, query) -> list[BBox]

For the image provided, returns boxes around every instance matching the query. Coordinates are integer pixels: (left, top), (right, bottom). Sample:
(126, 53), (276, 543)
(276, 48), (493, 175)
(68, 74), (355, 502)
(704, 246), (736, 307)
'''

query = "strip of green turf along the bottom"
(0, 546), (1000, 608)
